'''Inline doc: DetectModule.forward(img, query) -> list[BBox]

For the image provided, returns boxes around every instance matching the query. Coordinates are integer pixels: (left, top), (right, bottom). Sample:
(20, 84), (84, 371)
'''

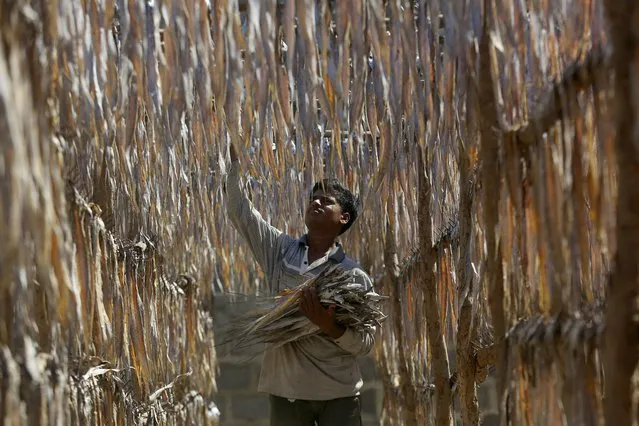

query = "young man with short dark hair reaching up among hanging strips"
(226, 145), (375, 426)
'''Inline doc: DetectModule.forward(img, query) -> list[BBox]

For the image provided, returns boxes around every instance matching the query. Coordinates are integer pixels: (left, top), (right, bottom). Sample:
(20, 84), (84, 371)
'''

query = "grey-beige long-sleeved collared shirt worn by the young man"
(226, 162), (376, 400)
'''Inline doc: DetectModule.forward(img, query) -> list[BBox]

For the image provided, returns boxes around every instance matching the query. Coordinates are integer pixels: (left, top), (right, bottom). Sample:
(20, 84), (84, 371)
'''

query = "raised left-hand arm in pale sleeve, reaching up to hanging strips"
(226, 145), (293, 276)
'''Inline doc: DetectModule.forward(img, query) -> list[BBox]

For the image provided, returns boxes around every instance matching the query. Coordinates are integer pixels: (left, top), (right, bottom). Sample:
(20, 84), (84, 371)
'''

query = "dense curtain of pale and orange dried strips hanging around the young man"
(0, 0), (632, 425)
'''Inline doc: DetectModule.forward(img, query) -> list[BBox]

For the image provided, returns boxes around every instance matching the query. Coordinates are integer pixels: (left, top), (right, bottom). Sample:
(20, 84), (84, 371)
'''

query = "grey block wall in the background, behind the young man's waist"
(213, 296), (498, 426)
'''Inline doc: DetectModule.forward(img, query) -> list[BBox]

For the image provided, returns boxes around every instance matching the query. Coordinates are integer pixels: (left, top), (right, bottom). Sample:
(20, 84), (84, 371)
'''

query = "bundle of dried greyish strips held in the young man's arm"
(224, 265), (387, 351)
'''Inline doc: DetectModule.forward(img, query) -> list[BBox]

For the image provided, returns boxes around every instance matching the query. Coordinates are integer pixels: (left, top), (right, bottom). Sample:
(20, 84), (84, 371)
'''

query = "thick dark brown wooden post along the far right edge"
(603, 0), (639, 426)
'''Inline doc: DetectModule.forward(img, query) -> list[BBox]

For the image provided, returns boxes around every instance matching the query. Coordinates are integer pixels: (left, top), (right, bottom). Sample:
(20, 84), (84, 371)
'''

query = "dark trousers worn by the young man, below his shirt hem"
(270, 395), (362, 426)
